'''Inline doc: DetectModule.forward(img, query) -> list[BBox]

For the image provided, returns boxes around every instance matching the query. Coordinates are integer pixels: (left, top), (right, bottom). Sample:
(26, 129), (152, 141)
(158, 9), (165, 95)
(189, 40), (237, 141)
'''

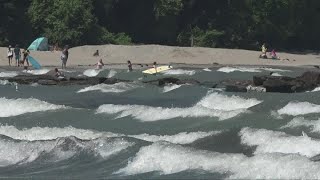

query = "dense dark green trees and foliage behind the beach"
(0, 0), (320, 49)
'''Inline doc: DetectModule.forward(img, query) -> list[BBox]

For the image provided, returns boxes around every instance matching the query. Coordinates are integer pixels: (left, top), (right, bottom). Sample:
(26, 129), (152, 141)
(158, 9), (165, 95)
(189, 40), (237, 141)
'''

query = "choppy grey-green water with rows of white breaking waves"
(0, 67), (320, 179)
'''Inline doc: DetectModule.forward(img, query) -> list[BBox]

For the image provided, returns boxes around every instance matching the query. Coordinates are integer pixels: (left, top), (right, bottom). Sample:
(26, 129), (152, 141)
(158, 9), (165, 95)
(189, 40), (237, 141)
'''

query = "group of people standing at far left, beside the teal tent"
(7, 44), (30, 67)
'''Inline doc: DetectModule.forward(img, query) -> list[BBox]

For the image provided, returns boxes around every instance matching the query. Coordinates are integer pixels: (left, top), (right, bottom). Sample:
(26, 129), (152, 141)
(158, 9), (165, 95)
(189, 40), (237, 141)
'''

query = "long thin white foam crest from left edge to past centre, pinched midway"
(0, 125), (221, 144)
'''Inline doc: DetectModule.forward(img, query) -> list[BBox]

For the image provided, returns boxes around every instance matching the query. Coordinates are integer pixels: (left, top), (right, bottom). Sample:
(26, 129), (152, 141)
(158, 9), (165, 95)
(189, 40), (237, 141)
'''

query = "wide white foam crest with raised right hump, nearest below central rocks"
(96, 93), (262, 121)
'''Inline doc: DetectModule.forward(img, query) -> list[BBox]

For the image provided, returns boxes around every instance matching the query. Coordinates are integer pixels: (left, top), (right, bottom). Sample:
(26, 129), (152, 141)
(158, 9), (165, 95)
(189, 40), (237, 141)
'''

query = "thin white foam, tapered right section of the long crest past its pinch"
(130, 131), (221, 144)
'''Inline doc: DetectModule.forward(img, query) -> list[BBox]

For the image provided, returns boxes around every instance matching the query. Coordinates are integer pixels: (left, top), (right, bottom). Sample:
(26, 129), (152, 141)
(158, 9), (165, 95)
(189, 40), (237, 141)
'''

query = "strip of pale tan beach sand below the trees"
(0, 45), (320, 67)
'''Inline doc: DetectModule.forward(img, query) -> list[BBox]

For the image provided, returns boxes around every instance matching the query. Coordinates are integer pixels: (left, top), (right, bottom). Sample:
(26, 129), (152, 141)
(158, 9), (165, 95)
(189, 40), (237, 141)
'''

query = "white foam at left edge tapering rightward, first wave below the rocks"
(0, 98), (67, 117)
